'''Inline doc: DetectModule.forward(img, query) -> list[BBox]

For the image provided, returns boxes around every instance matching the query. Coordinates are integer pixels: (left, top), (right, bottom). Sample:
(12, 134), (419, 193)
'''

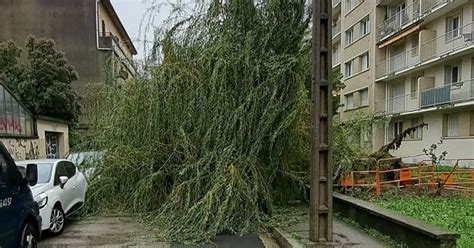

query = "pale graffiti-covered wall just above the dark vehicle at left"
(2, 138), (40, 161)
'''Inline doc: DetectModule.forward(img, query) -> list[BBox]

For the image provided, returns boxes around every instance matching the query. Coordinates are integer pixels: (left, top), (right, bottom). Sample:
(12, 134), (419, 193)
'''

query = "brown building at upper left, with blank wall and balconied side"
(0, 0), (137, 90)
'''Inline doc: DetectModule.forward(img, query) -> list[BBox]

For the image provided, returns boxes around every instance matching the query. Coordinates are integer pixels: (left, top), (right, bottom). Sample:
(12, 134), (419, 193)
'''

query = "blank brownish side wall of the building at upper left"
(0, 0), (102, 87)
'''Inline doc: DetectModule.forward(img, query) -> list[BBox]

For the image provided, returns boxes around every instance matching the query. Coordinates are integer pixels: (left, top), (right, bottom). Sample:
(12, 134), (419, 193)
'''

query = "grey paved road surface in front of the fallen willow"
(39, 216), (278, 248)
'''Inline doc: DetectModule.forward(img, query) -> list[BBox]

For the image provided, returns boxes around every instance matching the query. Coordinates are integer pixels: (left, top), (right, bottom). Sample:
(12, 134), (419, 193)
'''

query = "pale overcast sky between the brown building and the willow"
(111, 0), (171, 59)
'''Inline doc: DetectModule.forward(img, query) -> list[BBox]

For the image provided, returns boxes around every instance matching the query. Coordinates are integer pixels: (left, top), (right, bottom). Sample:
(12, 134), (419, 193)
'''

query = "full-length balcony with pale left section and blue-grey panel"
(375, 79), (474, 115)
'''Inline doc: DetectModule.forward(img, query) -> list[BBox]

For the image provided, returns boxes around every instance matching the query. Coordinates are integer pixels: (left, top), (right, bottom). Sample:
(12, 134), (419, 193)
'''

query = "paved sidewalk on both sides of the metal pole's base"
(274, 218), (390, 248)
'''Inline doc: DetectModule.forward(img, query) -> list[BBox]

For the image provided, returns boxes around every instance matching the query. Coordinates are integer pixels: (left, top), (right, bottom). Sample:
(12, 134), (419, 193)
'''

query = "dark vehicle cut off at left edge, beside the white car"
(0, 142), (41, 248)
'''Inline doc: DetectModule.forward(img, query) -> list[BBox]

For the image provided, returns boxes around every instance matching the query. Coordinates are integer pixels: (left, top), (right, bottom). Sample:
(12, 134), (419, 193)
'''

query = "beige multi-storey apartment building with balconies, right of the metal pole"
(332, 0), (474, 160)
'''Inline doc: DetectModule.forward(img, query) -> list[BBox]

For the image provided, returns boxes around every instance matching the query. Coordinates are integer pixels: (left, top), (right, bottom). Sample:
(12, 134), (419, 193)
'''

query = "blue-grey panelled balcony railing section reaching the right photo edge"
(420, 79), (474, 108)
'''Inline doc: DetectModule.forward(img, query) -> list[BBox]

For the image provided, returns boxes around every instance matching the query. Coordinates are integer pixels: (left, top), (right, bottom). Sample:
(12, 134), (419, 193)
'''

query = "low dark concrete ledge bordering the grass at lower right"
(333, 193), (459, 248)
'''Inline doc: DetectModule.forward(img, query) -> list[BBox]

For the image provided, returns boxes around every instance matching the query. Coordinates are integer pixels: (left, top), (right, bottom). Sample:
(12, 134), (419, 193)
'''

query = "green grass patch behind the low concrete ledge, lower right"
(374, 196), (474, 248)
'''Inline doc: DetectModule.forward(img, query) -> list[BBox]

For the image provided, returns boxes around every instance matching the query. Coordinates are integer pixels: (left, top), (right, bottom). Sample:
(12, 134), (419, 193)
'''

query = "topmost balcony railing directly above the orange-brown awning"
(377, 0), (420, 41)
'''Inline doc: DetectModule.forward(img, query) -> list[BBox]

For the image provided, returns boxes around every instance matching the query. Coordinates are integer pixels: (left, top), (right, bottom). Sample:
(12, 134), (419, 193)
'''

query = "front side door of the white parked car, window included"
(54, 161), (75, 213)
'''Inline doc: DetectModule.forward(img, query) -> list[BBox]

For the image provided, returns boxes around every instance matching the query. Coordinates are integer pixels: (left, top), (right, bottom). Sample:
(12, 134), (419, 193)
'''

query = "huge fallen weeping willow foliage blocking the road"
(88, 0), (309, 243)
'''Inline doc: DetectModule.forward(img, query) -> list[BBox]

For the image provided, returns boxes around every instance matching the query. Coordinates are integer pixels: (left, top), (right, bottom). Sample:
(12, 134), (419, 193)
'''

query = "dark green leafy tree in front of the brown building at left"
(0, 36), (80, 122)
